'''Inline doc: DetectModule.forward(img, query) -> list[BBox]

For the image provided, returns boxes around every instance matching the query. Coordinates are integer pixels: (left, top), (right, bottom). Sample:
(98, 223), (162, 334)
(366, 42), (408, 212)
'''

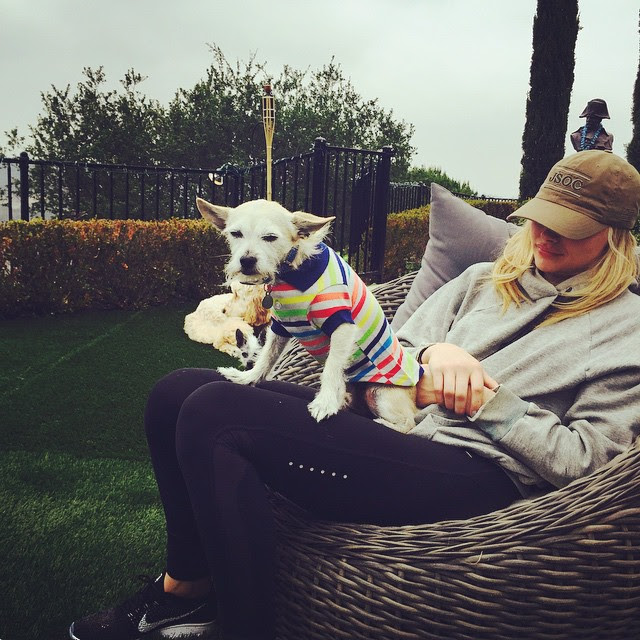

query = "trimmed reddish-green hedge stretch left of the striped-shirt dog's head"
(0, 220), (228, 318)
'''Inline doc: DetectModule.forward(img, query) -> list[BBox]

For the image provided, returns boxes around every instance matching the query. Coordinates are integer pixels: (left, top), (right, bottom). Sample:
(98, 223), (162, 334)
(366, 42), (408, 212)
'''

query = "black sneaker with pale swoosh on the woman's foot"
(69, 574), (217, 640)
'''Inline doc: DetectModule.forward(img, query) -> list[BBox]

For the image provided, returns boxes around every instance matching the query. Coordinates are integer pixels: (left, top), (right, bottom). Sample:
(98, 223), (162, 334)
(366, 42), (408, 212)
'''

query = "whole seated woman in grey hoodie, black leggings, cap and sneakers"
(70, 151), (640, 640)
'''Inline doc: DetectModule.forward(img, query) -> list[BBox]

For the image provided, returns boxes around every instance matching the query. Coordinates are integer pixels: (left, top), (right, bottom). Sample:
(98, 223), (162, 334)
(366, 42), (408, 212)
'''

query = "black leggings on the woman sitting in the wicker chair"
(145, 369), (519, 640)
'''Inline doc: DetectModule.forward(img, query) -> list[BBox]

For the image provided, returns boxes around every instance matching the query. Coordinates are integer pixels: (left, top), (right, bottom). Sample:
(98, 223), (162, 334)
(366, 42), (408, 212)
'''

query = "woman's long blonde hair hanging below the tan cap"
(491, 221), (638, 327)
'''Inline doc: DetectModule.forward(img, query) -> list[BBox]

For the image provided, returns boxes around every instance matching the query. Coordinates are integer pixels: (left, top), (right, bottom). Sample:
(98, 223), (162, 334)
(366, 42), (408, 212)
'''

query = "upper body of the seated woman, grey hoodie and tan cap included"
(399, 151), (640, 495)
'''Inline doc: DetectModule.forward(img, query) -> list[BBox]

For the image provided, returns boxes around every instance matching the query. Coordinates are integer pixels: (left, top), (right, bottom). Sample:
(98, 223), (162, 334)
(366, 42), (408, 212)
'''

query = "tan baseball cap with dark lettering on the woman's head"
(507, 150), (640, 240)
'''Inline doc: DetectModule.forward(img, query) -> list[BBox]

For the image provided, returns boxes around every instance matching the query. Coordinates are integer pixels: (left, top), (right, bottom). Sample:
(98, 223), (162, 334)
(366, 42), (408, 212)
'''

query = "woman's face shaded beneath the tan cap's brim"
(531, 220), (609, 285)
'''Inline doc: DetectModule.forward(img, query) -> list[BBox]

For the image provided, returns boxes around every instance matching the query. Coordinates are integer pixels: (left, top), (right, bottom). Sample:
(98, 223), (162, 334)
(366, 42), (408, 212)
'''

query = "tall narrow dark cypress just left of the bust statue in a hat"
(520, 0), (579, 199)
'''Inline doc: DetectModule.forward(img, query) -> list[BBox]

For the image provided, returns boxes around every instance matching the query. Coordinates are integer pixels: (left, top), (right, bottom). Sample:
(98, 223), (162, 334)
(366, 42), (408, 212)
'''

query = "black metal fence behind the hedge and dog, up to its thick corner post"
(0, 138), (393, 279)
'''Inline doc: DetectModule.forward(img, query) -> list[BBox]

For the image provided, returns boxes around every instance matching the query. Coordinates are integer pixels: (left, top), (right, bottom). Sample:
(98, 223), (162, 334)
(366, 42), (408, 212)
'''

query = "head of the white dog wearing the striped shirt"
(196, 198), (335, 284)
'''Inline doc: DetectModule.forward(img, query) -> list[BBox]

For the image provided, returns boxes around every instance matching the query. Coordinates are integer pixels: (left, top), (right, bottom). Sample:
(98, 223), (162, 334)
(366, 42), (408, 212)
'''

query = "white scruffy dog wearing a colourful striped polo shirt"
(197, 198), (422, 432)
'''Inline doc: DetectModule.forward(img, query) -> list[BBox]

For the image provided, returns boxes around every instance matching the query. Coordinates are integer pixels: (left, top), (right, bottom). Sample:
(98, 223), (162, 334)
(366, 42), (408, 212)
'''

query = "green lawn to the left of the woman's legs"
(0, 308), (234, 640)
